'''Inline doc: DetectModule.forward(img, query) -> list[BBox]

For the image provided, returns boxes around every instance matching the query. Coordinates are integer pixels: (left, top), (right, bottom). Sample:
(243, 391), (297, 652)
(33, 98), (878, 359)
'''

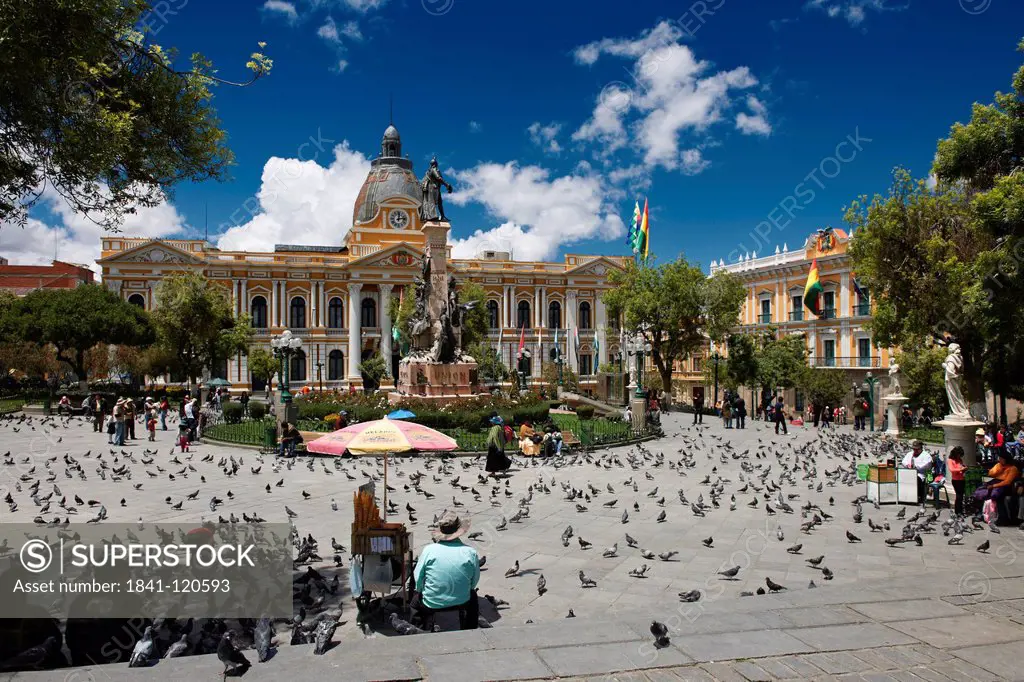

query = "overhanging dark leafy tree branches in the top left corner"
(0, 0), (271, 228)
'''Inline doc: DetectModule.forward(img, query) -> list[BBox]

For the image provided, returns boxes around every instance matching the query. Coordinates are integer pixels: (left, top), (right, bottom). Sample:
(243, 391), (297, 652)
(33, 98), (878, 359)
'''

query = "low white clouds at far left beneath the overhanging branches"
(0, 189), (185, 272)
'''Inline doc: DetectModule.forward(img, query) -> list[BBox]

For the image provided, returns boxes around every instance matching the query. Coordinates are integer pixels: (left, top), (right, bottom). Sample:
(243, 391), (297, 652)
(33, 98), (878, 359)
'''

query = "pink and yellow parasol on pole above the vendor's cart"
(306, 419), (459, 519)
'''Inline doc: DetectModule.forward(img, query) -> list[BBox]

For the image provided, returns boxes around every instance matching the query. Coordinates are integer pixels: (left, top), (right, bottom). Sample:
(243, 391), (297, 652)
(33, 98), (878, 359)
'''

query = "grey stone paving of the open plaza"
(0, 405), (1024, 680)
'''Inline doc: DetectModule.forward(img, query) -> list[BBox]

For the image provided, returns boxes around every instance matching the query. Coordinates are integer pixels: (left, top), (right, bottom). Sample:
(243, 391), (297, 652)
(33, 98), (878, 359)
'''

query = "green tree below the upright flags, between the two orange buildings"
(603, 256), (745, 403)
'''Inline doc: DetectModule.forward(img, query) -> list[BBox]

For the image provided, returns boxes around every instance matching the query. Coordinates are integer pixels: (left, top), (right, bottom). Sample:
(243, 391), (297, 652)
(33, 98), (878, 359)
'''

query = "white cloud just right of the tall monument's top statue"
(452, 162), (625, 260)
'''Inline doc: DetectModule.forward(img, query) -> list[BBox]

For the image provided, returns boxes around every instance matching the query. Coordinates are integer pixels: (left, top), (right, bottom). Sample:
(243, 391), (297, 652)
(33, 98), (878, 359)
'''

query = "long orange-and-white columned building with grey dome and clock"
(97, 126), (626, 390)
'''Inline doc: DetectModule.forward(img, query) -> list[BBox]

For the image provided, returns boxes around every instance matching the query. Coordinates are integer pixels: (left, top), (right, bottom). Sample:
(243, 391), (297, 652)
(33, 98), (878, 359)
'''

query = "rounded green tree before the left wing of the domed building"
(153, 272), (242, 382)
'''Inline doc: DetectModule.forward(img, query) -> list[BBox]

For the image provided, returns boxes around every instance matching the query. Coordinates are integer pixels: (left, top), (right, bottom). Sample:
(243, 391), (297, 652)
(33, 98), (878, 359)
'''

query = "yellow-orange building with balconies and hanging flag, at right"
(702, 228), (891, 409)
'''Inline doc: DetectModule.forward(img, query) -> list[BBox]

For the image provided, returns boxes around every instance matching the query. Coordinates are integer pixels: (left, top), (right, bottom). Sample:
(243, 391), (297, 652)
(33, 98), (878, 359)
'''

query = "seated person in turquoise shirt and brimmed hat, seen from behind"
(413, 511), (480, 630)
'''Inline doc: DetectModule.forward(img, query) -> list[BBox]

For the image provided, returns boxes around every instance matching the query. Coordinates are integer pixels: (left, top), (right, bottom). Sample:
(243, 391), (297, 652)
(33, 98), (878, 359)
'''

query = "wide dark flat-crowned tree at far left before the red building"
(0, 285), (154, 391)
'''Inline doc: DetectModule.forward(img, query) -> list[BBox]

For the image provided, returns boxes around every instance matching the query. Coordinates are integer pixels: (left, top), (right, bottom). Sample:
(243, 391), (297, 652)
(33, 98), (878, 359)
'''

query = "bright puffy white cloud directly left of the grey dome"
(217, 141), (370, 251)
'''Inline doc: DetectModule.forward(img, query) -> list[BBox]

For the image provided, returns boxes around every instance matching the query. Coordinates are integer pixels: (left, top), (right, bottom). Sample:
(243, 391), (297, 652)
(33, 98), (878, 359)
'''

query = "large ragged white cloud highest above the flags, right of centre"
(572, 22), (767, 173)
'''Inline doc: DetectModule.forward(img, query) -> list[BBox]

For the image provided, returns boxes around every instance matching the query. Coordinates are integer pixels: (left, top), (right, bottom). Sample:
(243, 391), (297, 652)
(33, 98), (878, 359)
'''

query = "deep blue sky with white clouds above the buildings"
(0, 0), (1024, 269)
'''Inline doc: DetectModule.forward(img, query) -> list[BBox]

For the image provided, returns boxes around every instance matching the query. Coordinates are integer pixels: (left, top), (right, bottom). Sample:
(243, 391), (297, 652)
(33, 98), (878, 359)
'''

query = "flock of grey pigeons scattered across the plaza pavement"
(0, 405), (998, 672)
